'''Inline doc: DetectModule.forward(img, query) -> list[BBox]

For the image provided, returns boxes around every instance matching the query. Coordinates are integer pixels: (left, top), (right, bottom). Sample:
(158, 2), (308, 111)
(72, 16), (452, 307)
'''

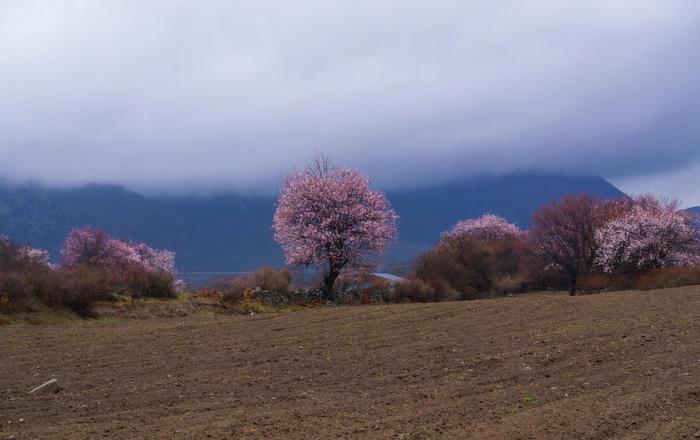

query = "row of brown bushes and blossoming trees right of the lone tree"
(413, 194), (700, 299)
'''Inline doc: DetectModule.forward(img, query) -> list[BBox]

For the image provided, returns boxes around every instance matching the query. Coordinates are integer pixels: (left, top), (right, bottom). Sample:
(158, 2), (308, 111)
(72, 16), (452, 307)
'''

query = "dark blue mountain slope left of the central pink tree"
(0, 185), (282, 271)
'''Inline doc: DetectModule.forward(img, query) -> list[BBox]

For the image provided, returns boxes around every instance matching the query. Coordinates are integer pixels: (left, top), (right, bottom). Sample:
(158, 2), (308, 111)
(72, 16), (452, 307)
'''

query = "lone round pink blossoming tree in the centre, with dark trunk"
(273, 157), (398, 300)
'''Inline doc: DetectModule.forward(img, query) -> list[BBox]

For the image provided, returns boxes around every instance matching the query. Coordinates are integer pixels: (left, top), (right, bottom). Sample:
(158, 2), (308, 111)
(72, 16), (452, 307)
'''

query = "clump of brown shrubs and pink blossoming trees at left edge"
(0, 228), (183, 314)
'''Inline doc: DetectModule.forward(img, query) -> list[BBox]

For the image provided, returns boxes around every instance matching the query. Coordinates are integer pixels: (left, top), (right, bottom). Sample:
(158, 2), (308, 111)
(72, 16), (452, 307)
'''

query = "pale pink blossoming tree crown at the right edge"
(595, 197), (700, 272)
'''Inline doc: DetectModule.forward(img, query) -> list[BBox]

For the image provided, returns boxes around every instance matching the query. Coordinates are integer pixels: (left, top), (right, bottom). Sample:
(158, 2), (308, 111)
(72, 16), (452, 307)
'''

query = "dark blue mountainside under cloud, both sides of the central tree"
(0, 174), (622, 272)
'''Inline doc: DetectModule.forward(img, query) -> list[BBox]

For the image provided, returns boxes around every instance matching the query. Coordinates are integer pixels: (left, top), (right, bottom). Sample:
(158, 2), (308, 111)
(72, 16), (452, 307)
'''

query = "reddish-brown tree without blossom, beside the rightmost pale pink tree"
(529, 194), (628, 295)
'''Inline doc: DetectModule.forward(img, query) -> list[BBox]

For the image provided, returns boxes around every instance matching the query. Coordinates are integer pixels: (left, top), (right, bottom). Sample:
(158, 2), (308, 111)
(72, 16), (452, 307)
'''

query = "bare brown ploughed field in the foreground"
(0, 287), (700, 440)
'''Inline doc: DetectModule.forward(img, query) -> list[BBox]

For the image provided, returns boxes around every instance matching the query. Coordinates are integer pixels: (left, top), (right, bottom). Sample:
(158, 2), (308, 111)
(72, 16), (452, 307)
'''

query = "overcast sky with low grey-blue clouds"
(0, 0), (700, 206)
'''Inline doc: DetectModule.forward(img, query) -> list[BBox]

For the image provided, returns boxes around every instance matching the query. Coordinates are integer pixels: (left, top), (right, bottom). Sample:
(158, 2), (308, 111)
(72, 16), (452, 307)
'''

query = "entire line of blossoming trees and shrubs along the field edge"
(0, 186), (700, 313)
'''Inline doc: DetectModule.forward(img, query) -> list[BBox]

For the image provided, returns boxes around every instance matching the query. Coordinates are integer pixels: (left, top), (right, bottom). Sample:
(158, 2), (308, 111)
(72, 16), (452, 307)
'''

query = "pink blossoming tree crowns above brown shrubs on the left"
(61, 227), (175, 274)
